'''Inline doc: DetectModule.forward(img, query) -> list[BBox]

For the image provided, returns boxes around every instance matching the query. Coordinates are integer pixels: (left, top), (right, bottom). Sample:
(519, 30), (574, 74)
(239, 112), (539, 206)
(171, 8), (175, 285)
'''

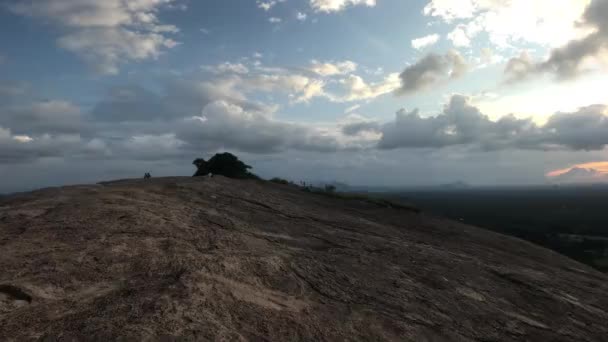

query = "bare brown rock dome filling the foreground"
(0, 177), (608, 341)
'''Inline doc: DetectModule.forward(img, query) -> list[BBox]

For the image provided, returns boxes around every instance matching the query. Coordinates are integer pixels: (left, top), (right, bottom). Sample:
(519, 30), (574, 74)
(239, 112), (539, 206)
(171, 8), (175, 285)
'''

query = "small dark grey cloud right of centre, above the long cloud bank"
(397, 50), (468, 95)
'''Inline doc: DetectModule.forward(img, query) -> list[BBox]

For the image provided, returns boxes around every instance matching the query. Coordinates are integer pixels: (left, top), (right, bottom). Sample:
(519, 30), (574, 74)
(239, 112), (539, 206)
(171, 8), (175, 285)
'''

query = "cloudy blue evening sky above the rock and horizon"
(0, 0), (608, 192)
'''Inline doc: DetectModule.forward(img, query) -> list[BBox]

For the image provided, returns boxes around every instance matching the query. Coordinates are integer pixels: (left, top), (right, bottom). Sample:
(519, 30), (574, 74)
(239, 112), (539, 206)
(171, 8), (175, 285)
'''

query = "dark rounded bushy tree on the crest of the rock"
(192, 153), (258, 178)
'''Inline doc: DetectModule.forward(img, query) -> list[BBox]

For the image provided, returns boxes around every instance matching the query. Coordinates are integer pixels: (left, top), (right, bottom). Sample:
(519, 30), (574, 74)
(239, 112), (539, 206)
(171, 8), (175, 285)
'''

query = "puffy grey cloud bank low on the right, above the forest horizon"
(378, 95), (608, 151)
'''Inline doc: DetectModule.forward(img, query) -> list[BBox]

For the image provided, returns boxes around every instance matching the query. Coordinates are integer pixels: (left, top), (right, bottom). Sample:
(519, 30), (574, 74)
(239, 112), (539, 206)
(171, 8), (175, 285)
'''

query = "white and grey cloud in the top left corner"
(8, 0), (179, 74)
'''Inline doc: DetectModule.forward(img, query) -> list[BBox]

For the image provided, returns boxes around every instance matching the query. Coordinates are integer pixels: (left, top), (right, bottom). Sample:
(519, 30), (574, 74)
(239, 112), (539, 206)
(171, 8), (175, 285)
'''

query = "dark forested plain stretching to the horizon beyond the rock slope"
(387, 186), (608, 272)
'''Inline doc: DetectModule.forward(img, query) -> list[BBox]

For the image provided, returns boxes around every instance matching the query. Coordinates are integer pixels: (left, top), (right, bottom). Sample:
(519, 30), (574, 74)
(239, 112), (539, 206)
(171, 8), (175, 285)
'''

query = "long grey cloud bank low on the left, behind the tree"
(0, 81), (360, 164)
